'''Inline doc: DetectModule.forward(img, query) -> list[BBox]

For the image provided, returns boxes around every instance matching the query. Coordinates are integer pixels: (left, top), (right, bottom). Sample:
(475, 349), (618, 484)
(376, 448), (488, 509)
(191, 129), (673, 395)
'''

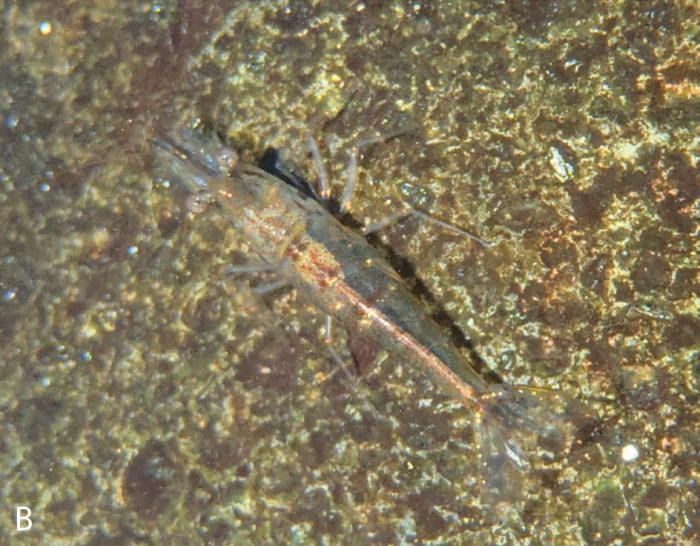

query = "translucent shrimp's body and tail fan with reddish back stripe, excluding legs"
(152, 129), (586, 488)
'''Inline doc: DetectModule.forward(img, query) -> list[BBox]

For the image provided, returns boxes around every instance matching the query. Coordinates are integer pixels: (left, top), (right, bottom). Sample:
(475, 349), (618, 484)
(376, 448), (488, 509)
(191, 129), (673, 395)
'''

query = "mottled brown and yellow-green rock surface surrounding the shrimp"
(0, 0), (700, 545)
